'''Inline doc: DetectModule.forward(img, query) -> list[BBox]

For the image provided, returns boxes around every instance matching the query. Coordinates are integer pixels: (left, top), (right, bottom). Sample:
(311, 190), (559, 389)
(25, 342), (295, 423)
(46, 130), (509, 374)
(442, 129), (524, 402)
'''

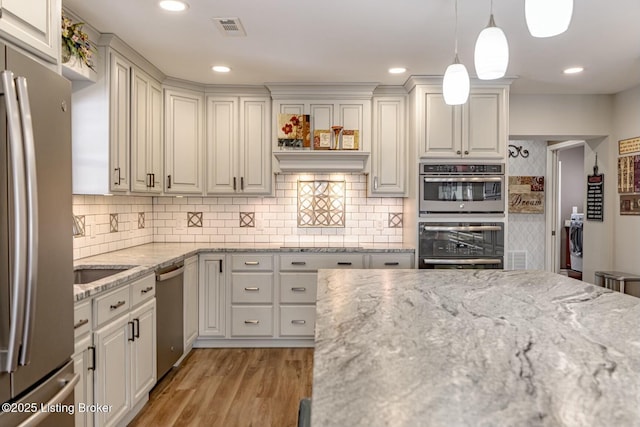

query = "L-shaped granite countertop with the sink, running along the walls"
(74, 243), (415, 301)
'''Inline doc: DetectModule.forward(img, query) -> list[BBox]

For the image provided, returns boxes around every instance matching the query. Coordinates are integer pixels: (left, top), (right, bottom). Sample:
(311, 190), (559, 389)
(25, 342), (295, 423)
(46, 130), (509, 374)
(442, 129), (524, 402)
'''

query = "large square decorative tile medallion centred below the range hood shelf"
(298, 181), (346, 227)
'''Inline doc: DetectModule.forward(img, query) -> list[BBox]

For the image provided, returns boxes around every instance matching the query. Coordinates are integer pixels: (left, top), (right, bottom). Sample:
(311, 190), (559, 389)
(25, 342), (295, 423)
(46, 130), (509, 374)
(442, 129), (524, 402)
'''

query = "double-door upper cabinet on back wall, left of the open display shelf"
(206, 95), (272, 195)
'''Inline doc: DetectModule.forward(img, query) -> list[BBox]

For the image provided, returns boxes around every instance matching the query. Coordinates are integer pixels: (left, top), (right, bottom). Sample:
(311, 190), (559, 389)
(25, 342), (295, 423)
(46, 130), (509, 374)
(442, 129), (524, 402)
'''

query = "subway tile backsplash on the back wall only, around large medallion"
(153, 174), (402, 246)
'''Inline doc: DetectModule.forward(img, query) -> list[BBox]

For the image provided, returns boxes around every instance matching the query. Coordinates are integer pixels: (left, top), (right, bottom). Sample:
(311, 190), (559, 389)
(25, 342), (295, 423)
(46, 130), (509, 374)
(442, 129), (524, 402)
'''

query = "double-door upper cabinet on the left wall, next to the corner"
(131, 67), (164, 193)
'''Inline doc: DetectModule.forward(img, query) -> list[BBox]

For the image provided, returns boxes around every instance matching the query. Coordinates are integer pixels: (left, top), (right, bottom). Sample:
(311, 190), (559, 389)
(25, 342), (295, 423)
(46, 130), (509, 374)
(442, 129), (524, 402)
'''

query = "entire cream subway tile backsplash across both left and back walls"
(73, 174), (402, 259)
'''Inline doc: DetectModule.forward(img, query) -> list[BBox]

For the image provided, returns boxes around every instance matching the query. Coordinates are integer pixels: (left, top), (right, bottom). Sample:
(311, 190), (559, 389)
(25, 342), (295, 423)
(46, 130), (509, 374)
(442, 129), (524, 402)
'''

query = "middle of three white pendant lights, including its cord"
(474, 0), (509, 80)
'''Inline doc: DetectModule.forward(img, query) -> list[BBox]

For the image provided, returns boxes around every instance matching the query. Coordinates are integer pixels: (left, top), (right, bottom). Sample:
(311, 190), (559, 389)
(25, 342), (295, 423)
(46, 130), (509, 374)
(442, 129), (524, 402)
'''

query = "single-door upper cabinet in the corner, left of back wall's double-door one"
(165, 89), (204, 193)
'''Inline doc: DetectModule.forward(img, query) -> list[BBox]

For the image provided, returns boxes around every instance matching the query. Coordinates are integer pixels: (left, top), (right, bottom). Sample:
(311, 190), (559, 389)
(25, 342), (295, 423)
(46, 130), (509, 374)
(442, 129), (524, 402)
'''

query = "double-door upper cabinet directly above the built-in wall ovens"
(416, 87), (508, 160)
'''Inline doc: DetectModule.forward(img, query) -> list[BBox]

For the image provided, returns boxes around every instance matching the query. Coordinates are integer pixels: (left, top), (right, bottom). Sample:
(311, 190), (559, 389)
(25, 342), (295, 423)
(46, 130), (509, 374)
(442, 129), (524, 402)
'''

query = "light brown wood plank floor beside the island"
(129, 348), (313, 427)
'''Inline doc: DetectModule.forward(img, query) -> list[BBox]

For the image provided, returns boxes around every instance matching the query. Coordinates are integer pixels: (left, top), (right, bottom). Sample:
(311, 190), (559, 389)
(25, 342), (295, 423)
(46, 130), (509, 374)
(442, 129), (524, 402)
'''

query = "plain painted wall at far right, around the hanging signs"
(608, 86), (640, 274)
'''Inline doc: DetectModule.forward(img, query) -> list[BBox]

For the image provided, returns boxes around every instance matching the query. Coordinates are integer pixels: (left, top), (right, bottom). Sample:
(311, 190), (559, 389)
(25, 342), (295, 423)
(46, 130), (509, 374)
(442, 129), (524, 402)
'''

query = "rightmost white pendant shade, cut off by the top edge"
(524, 0), (573, 37)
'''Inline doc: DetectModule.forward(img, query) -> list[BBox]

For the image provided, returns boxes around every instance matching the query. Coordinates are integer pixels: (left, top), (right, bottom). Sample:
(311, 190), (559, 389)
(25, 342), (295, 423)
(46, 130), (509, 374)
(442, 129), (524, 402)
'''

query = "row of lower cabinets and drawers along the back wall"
(196, 251), (414, 347)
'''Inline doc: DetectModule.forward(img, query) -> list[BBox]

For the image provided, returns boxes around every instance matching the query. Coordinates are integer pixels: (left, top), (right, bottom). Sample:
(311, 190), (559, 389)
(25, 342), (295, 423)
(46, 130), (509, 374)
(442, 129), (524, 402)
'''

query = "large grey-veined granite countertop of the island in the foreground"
(311, 270), (640, 427)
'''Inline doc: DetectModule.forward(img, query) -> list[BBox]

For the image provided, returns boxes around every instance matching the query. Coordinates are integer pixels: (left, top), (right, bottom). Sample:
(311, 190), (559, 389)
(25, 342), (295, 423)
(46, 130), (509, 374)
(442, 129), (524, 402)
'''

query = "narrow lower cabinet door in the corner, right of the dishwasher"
(198, 255), (226, 337)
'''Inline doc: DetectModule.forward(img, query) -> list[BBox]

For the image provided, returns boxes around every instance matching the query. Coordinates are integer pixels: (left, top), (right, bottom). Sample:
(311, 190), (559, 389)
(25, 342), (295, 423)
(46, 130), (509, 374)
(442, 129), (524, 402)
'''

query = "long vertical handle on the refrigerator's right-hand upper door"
(15, 77), (38, 365)
